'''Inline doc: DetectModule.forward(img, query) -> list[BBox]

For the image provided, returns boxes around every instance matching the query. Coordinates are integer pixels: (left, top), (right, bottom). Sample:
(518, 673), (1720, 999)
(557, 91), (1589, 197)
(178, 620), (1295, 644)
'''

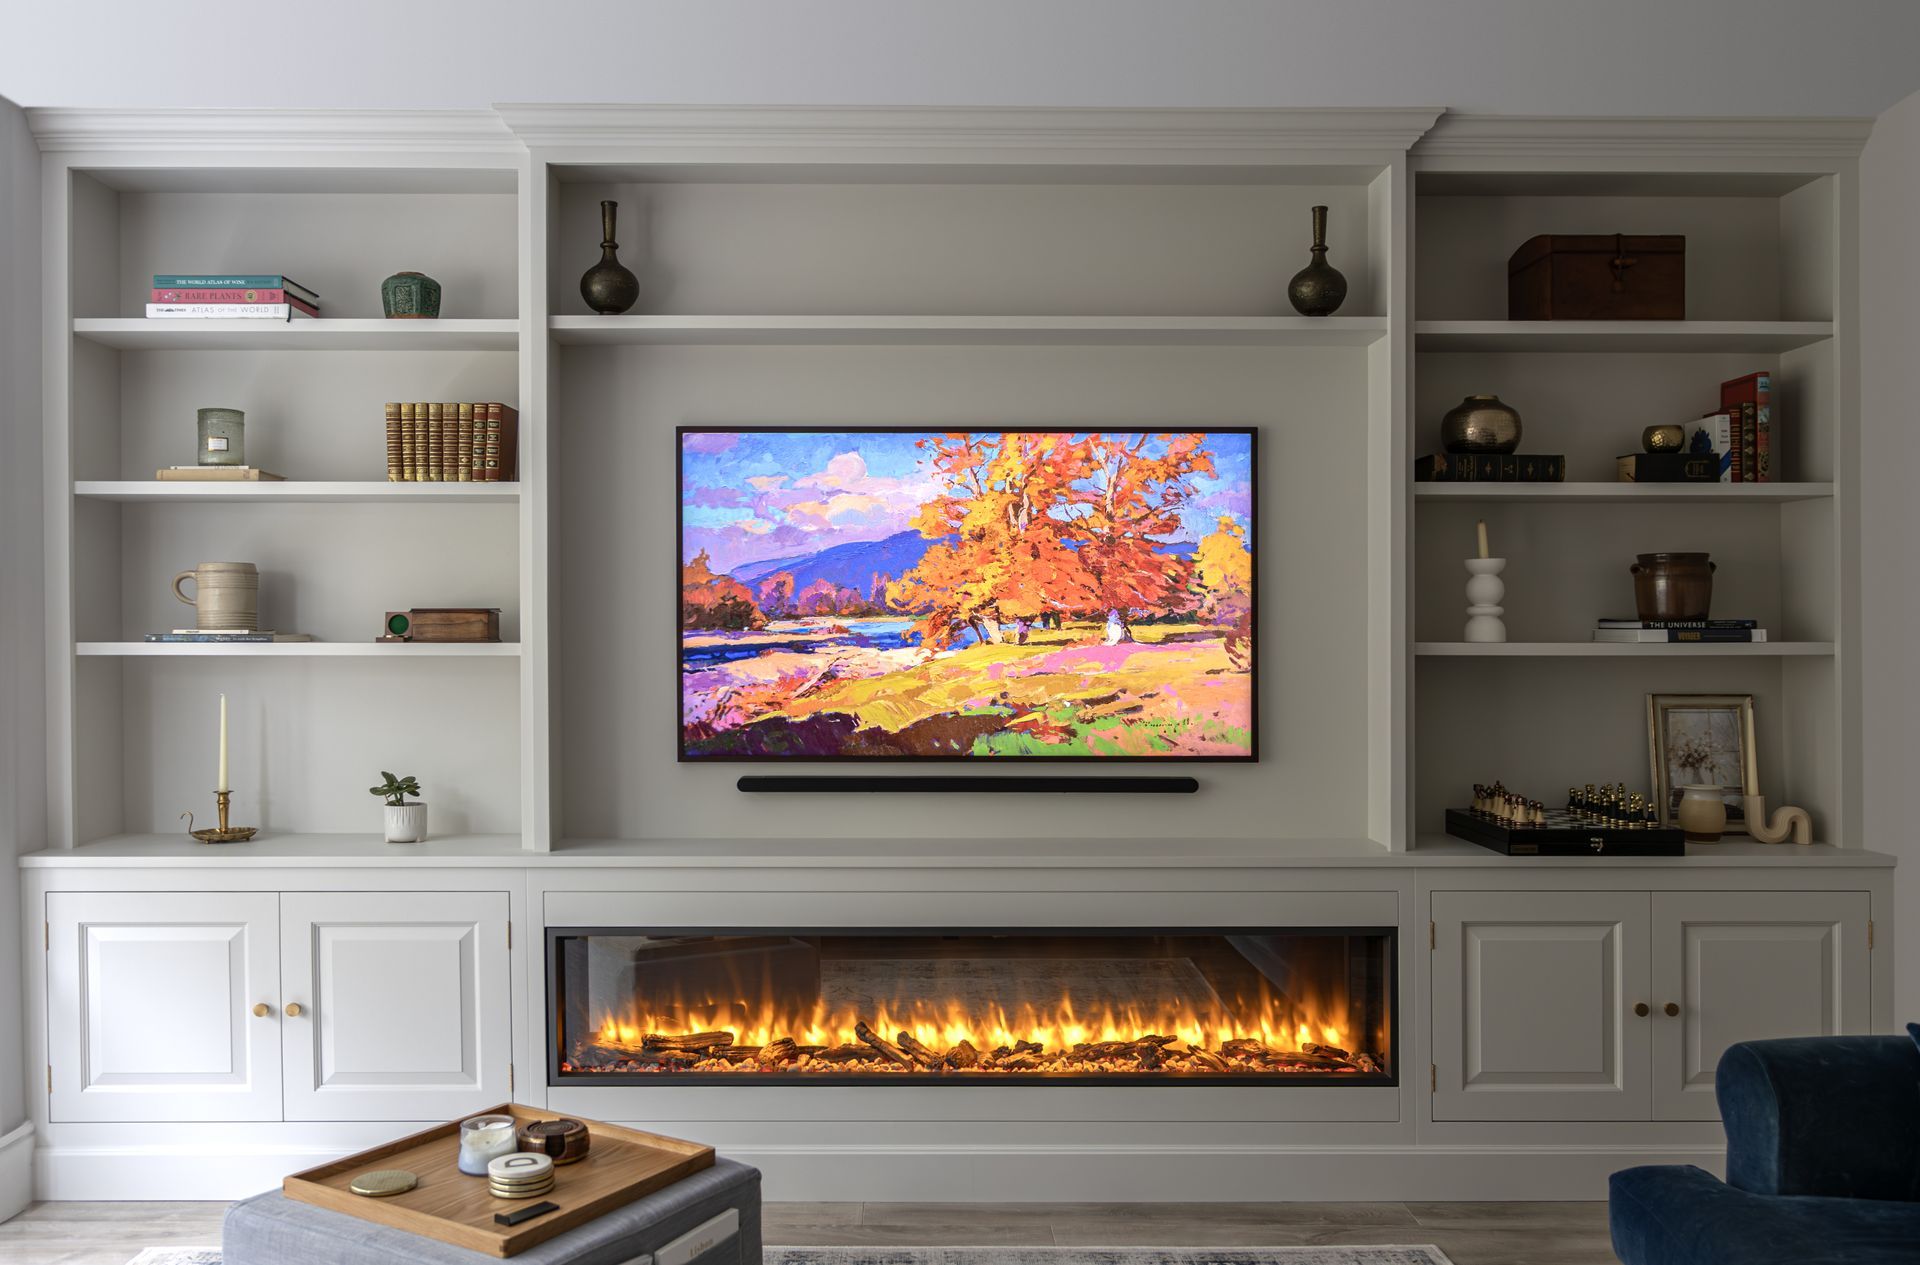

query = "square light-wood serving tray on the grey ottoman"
(280, 1104), (714, 1257)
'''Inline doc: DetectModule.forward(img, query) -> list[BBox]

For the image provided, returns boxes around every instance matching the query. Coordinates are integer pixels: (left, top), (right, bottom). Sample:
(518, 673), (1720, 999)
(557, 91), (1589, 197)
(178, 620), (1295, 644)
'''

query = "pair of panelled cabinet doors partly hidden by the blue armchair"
(1432, 891), (1872, 1121)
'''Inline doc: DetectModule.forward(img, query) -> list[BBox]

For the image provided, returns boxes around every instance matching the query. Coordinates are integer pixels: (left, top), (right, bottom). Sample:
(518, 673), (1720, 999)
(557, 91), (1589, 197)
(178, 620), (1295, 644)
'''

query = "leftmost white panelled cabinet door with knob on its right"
(46, 893), (280, 1121)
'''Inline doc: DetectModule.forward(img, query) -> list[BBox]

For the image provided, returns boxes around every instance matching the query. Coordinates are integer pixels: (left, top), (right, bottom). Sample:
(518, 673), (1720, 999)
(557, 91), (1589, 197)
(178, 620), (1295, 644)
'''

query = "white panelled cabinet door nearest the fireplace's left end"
(280, 893), (513, 1121)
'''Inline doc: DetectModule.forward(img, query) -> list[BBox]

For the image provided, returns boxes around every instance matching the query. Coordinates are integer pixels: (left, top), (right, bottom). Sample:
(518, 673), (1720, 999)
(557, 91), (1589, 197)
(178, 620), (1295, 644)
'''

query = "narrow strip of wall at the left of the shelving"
(0, 98), (46, 1219)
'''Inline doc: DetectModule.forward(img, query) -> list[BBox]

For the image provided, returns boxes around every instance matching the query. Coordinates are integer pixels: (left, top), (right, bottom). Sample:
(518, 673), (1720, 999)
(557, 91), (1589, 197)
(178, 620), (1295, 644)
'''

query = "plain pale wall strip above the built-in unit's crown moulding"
(0, 0), (1920, 115)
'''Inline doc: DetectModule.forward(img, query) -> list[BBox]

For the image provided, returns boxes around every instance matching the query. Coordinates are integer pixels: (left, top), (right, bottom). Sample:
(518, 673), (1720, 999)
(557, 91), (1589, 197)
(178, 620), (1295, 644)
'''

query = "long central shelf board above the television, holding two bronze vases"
(547, 317), (1386, 347)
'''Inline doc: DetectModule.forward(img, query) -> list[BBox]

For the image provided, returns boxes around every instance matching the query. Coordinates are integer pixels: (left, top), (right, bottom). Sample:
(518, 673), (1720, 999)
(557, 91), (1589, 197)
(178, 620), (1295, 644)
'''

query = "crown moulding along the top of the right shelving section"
(1413, 113), (1874, 159)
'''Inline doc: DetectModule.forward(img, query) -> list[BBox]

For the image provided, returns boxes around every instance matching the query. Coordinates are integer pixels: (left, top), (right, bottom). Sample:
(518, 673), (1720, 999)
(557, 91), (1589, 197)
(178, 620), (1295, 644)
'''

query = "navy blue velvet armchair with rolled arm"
(1609, 1035), (1920, 1265)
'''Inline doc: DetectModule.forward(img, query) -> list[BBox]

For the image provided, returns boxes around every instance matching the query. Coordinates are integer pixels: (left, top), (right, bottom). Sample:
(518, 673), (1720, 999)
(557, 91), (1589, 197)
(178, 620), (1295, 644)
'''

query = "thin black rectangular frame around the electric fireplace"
(543, 923), (1400, 1088)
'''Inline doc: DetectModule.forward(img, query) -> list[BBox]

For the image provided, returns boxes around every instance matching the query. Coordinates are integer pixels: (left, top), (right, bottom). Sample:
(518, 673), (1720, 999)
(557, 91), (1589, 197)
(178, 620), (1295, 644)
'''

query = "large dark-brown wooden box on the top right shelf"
(1507, 234), (1686, 321)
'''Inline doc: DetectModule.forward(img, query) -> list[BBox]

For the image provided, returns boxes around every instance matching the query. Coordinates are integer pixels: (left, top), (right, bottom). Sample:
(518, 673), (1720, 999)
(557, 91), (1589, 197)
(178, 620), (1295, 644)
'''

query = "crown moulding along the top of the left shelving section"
(27, 109), (524, 155)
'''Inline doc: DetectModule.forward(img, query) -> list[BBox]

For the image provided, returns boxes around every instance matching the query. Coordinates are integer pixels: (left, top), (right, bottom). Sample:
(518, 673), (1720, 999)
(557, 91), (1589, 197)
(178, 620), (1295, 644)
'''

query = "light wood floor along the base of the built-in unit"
(0, 1204), (1615, 1265)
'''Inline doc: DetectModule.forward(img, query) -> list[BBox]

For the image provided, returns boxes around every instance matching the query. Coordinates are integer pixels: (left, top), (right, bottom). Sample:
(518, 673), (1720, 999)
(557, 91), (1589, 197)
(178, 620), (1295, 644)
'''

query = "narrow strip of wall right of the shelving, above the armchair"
(1860, 83), (1920, 1021)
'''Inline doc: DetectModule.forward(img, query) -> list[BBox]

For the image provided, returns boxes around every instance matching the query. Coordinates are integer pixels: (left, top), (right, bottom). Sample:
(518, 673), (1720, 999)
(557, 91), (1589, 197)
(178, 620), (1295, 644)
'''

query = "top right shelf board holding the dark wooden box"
(1413, 321), (1834, 355)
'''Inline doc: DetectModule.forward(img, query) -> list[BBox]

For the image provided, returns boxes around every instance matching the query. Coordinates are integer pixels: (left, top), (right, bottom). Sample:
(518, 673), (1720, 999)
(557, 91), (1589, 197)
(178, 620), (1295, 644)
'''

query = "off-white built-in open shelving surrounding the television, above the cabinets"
(36, 107), (1862, 852)
